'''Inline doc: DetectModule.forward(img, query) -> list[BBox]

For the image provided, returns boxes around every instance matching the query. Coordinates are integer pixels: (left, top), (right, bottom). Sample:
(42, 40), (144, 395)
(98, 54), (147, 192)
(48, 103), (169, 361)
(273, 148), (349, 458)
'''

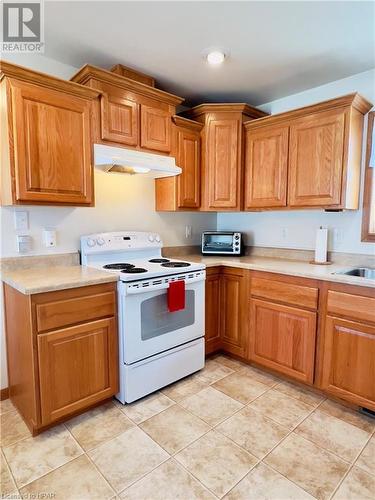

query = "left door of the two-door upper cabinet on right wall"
(245, 127), (289, 209)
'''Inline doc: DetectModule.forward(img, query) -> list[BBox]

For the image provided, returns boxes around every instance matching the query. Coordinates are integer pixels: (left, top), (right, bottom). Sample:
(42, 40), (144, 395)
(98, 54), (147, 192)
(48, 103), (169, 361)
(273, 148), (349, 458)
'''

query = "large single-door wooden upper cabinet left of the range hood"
(0, 62), (99, 206)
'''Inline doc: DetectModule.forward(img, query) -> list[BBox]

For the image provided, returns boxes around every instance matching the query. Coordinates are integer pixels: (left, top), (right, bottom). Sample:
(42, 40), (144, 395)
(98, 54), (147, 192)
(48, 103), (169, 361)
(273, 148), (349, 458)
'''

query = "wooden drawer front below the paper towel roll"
(251, 278), (318, 309)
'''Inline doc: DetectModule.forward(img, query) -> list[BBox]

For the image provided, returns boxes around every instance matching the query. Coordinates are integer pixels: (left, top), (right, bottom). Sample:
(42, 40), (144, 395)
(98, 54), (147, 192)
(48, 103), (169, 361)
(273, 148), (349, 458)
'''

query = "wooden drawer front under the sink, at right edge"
(327, 290), (375, 323)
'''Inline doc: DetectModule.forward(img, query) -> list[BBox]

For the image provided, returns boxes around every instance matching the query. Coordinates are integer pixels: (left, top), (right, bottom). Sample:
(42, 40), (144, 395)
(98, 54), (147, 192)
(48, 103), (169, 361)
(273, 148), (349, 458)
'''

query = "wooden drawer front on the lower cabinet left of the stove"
(36, 291), (116, 332)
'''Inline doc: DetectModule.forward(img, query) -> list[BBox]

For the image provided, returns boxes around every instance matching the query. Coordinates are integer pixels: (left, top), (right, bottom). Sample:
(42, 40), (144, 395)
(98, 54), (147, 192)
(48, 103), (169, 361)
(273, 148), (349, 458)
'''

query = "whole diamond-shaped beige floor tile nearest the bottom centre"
(176, 431), (257, 497)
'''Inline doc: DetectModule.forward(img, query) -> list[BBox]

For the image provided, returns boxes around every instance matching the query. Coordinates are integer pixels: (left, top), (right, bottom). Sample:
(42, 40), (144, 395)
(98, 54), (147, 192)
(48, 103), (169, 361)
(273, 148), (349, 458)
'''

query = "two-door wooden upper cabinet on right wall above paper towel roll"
(245, 94), (371, 210)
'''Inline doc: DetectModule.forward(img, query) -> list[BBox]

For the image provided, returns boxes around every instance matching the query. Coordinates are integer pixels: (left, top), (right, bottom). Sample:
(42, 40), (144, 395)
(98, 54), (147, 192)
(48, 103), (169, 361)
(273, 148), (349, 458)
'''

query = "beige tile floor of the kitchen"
(0, 355), (375, 500)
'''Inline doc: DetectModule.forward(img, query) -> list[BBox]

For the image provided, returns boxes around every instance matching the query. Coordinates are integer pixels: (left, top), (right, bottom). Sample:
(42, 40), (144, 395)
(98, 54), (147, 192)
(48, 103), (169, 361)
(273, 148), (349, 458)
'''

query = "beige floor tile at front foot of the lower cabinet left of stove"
(3, 425), (83, 488)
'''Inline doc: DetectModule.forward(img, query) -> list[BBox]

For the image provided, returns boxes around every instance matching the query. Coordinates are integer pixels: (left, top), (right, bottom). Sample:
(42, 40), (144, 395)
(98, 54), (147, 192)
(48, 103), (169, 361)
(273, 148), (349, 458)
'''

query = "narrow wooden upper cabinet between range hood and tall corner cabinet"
(155, 116), (203, 211)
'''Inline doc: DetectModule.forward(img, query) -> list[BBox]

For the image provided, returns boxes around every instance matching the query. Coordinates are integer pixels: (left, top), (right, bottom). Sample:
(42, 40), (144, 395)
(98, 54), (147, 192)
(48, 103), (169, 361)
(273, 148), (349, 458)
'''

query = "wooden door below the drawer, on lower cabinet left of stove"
(37, 318), (118, 425)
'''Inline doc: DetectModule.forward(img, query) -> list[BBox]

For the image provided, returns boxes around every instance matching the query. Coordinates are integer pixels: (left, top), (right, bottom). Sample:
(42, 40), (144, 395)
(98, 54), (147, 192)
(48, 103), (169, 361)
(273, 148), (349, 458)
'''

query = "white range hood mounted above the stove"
(94, 144), (182, 179)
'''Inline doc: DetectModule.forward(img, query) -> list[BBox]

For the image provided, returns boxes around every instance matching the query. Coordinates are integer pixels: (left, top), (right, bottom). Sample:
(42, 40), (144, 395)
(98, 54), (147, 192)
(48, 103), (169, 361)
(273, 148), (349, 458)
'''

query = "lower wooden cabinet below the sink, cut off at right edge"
(320, 285), (375, 411)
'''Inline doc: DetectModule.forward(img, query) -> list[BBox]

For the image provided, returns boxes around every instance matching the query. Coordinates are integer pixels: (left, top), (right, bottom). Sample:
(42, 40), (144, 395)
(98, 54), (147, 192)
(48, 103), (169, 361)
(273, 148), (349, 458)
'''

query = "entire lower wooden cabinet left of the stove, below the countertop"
(4, 283), (118, 434)
